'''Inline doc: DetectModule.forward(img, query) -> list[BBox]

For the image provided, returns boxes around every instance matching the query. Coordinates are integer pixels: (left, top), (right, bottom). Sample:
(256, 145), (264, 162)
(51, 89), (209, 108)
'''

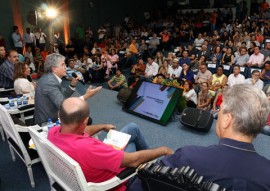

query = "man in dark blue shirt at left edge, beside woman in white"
(0, 50), (19, 89)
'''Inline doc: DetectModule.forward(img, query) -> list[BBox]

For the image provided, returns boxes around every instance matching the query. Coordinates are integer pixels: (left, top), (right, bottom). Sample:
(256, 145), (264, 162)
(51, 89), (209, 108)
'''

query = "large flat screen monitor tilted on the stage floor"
(123, 81), (183, 125)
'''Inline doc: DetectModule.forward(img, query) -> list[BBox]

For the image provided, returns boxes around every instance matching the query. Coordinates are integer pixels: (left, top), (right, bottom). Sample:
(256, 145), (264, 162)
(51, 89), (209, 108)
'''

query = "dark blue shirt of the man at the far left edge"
(0, 59), (14, 88)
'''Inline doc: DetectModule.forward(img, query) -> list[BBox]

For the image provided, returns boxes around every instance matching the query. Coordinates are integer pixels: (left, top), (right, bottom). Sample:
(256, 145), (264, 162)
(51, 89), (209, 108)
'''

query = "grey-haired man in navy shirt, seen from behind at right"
(161, 84), (270, 191)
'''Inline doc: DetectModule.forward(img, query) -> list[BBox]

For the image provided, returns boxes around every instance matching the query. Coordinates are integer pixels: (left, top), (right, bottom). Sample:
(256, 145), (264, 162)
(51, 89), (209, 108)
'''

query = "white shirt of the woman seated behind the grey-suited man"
(14, 78), (35, 94)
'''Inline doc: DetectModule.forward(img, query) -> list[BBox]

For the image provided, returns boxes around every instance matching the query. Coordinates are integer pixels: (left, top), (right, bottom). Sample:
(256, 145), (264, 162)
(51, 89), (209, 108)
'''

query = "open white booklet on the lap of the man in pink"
(103, 130), (131, 150)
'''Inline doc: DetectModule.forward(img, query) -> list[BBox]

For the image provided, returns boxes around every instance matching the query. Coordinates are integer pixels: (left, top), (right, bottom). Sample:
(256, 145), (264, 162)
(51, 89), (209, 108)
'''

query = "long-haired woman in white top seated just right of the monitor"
(183, 80), (198, 108)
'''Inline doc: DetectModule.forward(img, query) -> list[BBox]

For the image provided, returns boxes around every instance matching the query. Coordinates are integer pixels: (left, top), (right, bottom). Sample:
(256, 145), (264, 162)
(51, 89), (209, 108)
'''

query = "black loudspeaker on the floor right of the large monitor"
(180, 107), (214, 132)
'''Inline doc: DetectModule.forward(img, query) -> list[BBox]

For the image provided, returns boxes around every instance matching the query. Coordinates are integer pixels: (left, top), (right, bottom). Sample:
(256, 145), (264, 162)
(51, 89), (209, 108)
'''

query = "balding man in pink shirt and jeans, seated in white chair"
(48, 98), (173, 191)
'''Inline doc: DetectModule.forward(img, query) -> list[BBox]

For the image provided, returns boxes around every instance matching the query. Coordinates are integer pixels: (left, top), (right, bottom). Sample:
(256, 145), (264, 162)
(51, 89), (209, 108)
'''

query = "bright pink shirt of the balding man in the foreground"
(48, 126), (126, 191)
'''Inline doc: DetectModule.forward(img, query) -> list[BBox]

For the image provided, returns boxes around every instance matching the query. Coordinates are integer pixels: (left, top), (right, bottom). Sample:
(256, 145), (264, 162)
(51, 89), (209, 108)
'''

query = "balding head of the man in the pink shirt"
(59, 97), (90, 124)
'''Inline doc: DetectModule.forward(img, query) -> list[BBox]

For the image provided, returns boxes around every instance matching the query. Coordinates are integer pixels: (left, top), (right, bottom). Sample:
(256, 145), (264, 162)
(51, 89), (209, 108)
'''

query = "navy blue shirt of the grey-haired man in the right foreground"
(161, 138), (270, 191)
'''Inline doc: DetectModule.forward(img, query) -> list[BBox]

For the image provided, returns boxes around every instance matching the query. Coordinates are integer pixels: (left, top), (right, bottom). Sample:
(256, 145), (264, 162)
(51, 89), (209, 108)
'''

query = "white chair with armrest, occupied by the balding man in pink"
(29, 127), (136, 191)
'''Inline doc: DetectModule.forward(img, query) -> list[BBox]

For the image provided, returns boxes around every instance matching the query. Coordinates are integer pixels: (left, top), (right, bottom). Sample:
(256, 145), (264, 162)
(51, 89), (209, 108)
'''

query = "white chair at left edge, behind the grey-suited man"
(0, 105), (41, 187)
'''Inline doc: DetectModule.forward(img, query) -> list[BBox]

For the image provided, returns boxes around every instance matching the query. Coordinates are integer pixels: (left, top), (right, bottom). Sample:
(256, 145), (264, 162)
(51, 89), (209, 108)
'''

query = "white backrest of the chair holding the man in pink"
(29, 127), (87, 191)
